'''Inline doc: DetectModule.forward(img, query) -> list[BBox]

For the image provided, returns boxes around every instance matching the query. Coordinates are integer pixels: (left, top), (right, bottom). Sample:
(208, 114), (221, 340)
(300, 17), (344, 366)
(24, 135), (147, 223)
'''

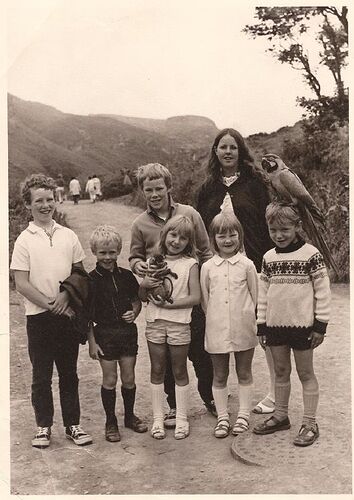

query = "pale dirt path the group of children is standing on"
(10, 201), (351, 495)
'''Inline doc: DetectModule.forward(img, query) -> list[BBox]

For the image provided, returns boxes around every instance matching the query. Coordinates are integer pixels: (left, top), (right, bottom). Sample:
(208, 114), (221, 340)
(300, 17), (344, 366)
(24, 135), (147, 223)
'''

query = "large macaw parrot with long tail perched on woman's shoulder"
(262, 154), (338, 275)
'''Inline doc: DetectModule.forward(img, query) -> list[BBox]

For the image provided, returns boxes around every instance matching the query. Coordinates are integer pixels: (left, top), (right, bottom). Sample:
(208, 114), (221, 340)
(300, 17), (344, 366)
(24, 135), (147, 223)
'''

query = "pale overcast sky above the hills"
(7, 0), (346, 136)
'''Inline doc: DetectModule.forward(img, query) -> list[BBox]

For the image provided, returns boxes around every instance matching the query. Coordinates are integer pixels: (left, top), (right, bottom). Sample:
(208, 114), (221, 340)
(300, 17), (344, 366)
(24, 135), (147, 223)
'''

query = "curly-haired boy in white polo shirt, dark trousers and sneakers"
(10, 174), (92, 448)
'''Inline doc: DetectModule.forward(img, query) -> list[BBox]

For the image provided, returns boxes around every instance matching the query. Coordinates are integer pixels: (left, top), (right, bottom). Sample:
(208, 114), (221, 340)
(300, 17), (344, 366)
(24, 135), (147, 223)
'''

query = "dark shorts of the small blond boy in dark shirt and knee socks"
(94, 324), (138, 361)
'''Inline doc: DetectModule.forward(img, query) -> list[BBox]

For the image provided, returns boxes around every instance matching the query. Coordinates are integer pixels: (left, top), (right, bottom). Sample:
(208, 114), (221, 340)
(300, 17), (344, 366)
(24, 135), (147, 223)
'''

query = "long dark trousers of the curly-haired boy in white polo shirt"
(27, 312), (80, 427)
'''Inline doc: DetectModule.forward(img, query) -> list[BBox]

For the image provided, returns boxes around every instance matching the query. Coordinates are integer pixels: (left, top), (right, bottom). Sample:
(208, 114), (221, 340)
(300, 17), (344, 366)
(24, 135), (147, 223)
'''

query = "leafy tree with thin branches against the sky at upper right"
(243, 7), (348, 121)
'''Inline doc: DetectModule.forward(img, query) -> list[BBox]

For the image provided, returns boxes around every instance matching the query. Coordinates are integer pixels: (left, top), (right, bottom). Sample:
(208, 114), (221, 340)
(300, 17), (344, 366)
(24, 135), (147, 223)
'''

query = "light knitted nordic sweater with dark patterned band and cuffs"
(257, 240), (331, 335)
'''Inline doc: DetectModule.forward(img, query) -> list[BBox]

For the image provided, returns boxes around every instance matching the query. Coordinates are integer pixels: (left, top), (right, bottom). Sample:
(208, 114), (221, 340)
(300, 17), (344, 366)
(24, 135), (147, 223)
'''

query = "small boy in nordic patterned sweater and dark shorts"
(253, 203), (330, 446)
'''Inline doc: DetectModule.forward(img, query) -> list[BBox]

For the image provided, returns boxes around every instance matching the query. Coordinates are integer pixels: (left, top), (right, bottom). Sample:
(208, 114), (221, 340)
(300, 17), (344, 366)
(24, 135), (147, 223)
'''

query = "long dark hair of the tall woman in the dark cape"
(203, 128), (269, 189)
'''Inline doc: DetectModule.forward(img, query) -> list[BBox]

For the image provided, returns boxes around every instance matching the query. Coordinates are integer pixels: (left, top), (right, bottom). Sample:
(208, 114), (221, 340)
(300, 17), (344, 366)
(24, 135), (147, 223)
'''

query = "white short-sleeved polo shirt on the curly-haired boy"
(10, 222), (85, 315)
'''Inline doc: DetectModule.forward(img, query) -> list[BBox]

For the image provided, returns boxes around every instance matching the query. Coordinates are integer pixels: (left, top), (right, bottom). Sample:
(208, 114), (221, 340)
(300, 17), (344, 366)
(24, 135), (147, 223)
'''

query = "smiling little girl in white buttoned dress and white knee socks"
(200, 213), (258, 438)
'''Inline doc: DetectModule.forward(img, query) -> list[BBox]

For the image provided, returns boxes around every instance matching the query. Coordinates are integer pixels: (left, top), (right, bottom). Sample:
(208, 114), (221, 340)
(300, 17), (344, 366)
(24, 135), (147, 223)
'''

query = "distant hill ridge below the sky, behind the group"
(8, 94), (302, 193)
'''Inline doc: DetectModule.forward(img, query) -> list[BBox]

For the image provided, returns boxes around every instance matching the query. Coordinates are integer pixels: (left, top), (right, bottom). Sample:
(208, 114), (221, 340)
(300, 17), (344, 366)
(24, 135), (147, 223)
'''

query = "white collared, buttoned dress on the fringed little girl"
(200, 252), (258, 354)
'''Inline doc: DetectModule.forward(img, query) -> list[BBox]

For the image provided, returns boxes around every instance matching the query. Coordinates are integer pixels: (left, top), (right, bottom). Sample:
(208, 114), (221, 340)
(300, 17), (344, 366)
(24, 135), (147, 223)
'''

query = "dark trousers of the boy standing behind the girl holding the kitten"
(164, 305), (213, 408)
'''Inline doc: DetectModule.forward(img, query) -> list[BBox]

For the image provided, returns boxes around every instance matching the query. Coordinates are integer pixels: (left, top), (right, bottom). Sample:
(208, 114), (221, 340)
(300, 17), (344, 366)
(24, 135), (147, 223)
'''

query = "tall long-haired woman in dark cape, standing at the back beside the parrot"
(197, 128), (275, 413)
